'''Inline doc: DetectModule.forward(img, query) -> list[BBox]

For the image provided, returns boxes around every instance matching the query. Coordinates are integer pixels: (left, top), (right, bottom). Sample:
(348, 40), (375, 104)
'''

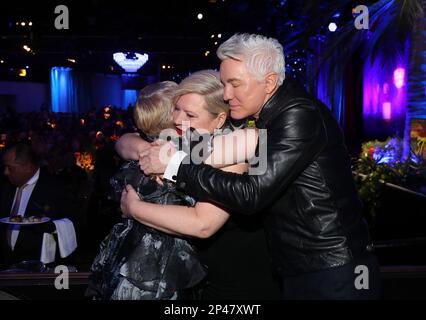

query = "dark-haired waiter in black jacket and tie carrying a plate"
(0, 143), (71, 268)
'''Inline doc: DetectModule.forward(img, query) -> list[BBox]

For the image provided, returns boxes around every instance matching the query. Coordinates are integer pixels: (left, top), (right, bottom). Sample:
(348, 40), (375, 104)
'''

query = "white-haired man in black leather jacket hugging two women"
(136, 34), (380, 299)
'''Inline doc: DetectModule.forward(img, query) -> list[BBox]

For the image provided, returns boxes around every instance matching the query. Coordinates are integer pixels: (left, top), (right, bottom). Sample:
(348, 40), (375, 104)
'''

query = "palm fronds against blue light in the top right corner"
(284, 0), (425, 75)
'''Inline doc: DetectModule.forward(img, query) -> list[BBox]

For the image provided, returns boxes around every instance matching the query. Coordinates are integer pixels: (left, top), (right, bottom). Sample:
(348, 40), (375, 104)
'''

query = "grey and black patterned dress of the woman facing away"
(86, 144), (206, 300)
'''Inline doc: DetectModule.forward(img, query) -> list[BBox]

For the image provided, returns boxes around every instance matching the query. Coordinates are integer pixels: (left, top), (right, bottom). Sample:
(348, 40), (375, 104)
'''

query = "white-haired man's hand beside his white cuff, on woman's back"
(139, 140), (176, 174)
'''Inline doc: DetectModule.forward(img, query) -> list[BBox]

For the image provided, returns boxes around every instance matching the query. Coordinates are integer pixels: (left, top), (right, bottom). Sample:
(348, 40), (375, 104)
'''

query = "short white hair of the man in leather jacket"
(216, 33), (285, 85)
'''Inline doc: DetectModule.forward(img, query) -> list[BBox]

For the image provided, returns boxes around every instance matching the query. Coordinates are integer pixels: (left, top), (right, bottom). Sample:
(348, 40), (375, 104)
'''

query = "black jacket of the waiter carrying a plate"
(0, 168), (73, 266)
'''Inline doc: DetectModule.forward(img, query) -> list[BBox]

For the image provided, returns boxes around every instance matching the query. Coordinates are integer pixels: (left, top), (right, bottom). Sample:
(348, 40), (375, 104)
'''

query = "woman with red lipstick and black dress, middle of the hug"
(116, 70), (278, 299)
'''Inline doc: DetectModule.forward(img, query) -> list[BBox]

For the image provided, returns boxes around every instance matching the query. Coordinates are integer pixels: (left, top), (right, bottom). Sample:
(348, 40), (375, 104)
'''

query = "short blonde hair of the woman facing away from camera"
(133, 81), (177, 136)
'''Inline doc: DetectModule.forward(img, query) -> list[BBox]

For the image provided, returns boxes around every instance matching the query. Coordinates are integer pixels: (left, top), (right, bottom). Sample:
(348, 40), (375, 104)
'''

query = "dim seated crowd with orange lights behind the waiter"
(0, 106), (136, 263)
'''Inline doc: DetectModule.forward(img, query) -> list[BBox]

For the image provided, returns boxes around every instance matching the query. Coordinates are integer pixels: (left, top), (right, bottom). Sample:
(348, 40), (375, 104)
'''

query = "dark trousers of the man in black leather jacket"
(282, 253), (381, 300)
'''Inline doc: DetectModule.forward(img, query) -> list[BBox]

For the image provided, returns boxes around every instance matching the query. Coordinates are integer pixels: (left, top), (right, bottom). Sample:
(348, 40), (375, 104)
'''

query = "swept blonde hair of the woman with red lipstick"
(173, 70), (229, 117)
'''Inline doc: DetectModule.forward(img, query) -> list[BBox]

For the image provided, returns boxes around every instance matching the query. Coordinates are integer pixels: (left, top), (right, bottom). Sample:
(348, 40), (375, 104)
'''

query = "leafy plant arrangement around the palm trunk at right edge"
(355, 137), (426, 221)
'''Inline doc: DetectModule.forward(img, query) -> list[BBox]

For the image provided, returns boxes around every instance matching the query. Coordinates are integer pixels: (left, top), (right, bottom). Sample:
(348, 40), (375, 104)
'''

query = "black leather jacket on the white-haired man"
(177, 80), (369, 274)
